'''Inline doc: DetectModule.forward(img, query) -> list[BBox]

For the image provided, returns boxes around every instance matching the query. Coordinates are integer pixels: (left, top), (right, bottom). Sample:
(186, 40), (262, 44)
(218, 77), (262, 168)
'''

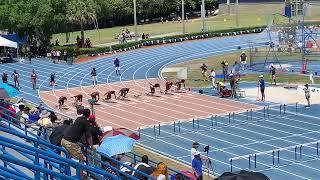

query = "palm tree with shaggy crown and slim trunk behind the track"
(67, 0), (97, 45)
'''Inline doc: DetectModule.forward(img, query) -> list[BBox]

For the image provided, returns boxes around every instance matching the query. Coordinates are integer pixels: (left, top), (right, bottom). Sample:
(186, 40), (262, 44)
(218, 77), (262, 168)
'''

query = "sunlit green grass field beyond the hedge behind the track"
(52, 3), (320, 46)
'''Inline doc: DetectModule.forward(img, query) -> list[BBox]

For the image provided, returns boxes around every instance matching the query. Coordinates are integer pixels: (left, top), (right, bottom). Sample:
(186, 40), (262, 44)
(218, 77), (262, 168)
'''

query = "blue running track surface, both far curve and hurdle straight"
(0, 34), (319, 179)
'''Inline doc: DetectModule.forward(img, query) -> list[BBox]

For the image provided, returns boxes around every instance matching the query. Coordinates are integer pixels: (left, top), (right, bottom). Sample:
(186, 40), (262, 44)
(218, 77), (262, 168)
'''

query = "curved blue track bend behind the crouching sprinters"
(0, 34), (266, 104)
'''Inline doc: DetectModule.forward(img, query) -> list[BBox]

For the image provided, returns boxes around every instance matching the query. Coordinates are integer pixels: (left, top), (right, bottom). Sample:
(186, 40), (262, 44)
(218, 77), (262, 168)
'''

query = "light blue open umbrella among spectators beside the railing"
(97, 134), (136, 156)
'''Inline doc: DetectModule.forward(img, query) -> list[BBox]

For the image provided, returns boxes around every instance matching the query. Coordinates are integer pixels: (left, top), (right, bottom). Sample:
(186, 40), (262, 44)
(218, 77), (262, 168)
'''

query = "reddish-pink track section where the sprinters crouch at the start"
(40, 79), (257, 130)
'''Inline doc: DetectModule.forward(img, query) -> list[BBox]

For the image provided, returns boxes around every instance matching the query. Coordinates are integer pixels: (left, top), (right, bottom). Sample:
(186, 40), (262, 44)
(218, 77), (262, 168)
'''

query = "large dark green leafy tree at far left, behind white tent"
(0, 0), (67, 46)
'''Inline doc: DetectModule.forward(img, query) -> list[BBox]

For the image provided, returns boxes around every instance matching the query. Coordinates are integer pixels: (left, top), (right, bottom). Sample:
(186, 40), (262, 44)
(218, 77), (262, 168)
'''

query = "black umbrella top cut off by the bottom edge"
(216, 170), (270, 180)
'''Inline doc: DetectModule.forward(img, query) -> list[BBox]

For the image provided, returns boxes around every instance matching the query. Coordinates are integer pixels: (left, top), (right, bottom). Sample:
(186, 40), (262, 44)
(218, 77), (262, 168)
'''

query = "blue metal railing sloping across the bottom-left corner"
(0, 136), (116, 179)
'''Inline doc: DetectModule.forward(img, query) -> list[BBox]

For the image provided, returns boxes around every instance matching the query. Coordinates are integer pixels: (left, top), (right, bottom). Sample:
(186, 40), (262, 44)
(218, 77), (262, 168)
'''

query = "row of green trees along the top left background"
(0, 0), (217, 46)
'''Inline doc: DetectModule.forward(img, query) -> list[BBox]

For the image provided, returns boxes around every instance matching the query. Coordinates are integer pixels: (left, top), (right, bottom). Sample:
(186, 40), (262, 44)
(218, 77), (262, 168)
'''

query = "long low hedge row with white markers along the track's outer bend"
(52, 26), (266, 56)
